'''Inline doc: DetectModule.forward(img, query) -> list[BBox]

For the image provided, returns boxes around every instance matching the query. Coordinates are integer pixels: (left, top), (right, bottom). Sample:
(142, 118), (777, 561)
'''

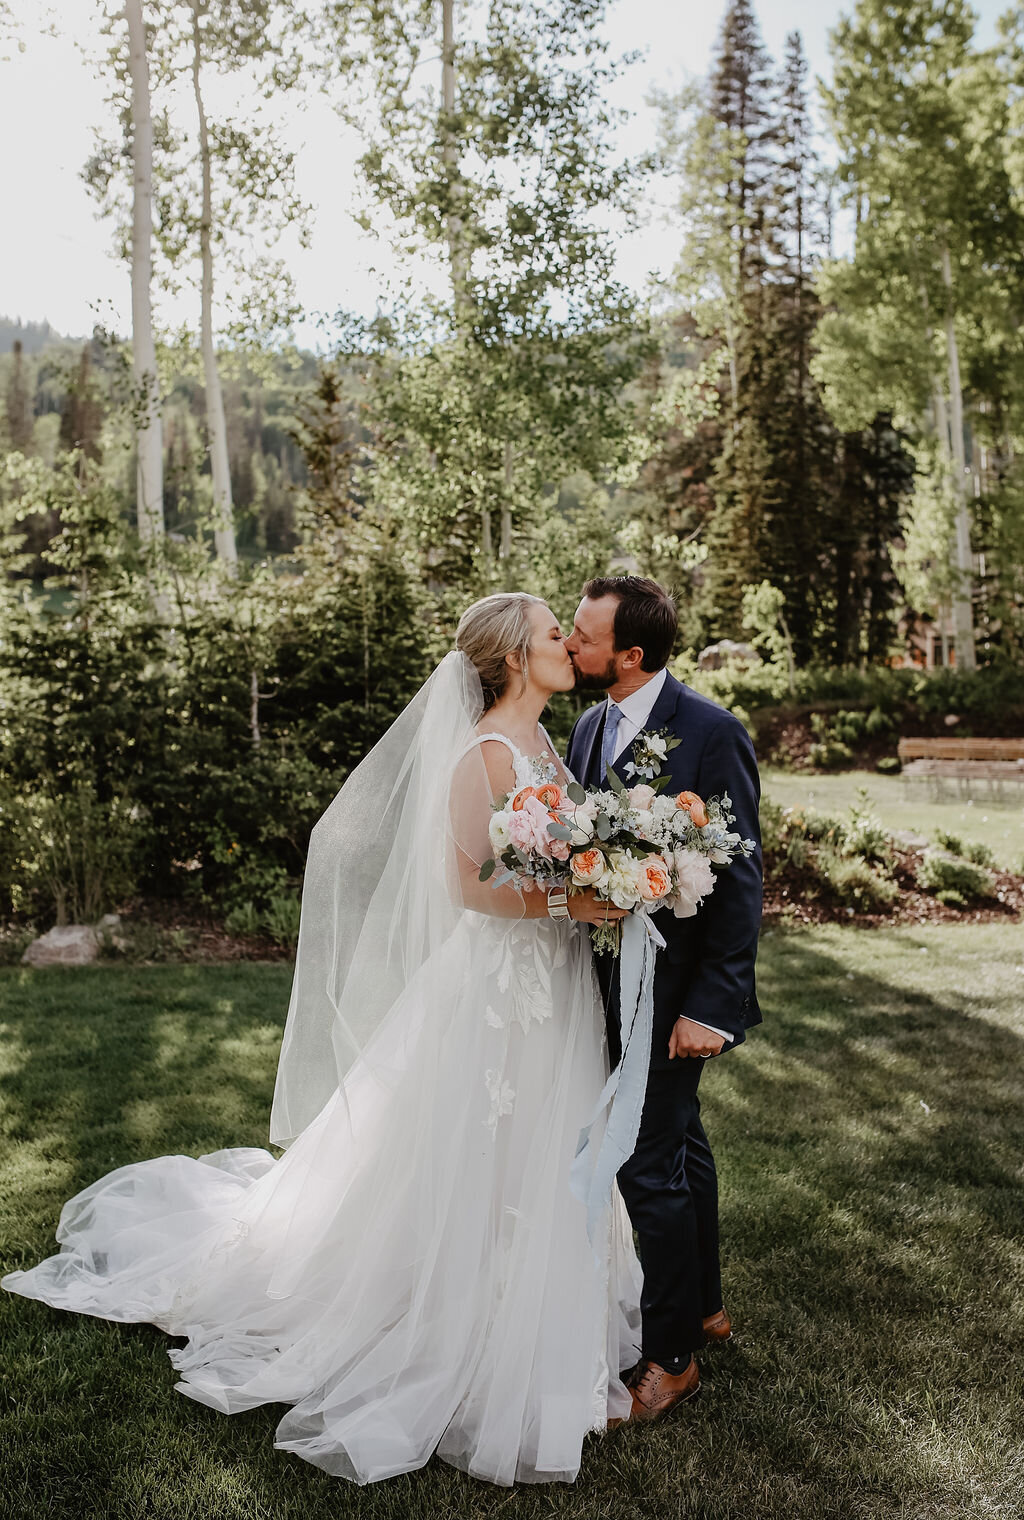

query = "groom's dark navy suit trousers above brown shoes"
(599, 958), (722, 1373)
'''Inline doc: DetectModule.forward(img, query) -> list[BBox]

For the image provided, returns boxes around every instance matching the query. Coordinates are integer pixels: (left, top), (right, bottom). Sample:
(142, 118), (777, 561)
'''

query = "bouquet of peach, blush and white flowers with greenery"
(480, 771), (754, 955)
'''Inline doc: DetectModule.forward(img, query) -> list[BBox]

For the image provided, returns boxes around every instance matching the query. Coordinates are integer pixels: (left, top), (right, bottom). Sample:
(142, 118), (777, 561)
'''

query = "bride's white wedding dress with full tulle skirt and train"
(5, 740), (640, 1484)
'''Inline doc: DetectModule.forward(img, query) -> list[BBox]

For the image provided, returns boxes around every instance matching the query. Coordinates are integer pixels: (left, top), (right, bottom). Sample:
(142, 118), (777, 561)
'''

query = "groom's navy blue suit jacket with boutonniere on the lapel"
(565, 675), (761, 1066)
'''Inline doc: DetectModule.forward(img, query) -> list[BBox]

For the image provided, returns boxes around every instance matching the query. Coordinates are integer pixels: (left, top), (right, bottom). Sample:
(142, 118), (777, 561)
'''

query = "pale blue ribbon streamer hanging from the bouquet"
(570, 914), (665, 1243)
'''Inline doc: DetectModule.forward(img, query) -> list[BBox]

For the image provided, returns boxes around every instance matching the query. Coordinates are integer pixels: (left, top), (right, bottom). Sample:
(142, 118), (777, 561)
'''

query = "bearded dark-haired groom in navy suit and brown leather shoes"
(565, 576), (761, 1420)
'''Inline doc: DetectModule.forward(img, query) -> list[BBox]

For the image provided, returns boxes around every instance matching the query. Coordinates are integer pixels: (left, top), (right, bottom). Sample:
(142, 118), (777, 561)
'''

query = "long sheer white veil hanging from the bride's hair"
(270, 652), (489, 1146)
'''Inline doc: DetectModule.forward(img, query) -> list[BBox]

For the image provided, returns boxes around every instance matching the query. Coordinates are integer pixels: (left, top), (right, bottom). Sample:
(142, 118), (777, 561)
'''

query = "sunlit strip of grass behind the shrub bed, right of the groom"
(761, 769), (1024, 872)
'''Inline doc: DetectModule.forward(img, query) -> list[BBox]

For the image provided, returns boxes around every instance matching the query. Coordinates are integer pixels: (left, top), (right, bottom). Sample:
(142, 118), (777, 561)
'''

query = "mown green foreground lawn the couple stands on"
(0, 924), (1024, 1520)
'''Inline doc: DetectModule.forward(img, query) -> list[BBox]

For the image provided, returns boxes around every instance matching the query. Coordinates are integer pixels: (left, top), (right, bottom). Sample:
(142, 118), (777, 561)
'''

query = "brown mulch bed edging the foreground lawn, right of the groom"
(764, 847), (1024, 926)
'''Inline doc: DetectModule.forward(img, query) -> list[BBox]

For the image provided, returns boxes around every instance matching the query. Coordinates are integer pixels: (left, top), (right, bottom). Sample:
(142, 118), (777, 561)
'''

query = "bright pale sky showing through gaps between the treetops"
(0, 0), (1009, 347)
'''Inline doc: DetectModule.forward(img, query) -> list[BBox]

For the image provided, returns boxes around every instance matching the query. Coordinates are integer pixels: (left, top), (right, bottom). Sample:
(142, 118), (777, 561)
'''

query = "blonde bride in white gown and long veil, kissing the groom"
(3, 593), (640, 1484)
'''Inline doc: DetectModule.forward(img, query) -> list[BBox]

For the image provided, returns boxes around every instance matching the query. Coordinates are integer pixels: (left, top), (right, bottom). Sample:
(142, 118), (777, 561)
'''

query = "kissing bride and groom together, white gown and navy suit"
(3, 576), (761, 1485)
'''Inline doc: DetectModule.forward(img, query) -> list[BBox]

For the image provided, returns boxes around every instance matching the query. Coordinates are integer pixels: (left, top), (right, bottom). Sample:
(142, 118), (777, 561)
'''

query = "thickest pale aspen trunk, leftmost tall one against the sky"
(125, 0), (164, 544)
